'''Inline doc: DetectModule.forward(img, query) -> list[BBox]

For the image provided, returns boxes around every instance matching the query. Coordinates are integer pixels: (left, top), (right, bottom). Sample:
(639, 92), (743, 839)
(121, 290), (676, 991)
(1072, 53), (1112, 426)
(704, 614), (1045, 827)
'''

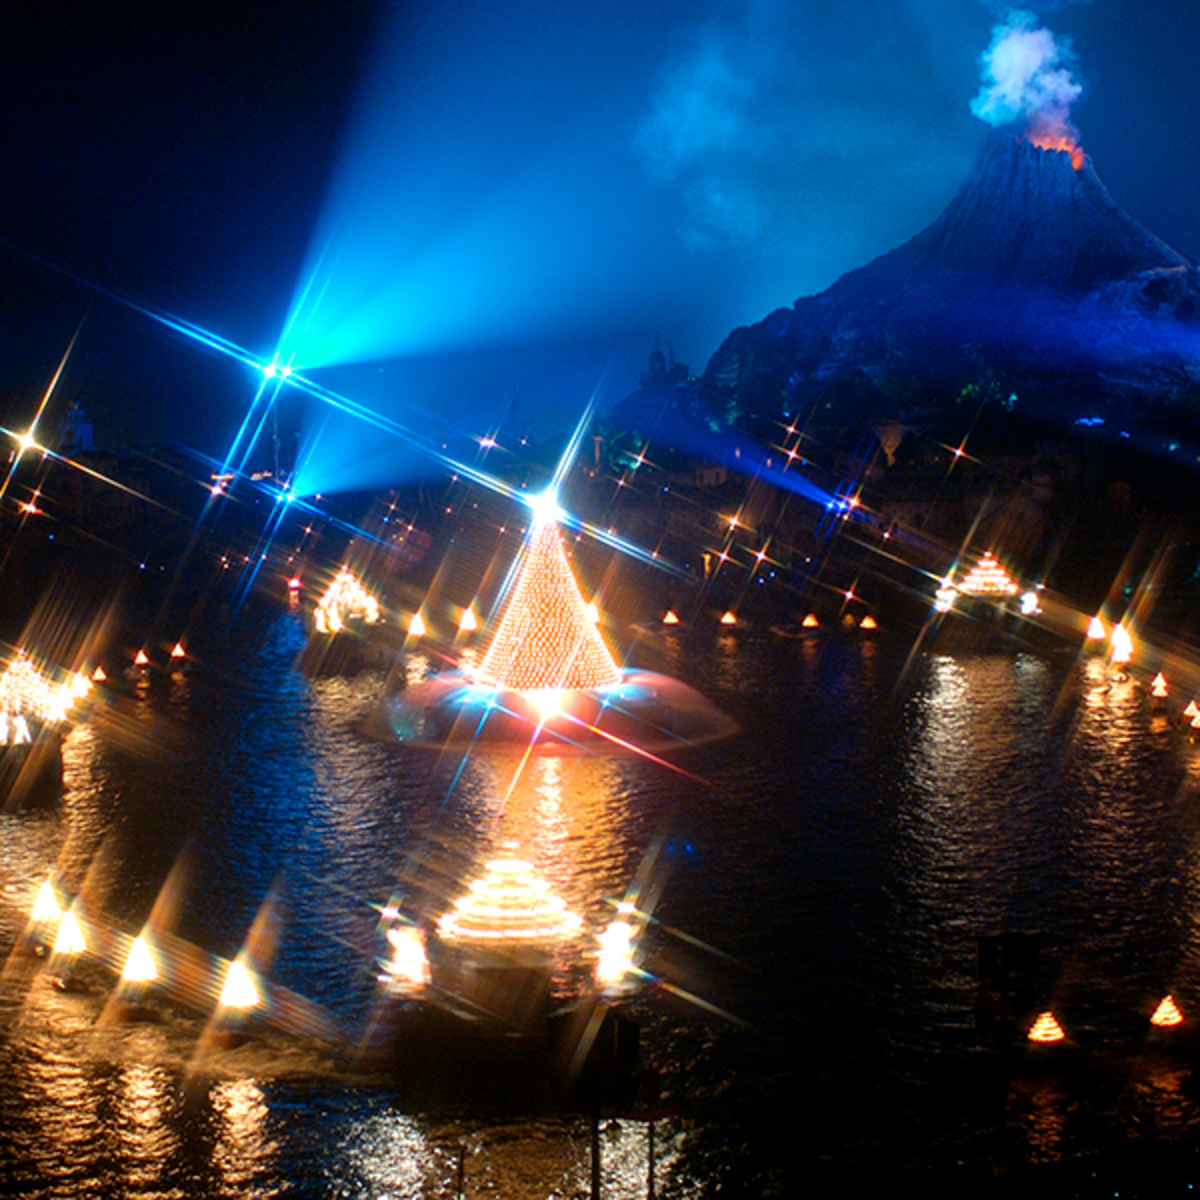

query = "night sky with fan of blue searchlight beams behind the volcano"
(0, 0), (1200, 468)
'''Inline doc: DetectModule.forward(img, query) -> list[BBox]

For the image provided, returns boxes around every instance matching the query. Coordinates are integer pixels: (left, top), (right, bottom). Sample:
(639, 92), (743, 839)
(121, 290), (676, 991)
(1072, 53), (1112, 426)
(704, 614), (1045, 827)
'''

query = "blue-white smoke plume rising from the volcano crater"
(971, 10), (1084, 144)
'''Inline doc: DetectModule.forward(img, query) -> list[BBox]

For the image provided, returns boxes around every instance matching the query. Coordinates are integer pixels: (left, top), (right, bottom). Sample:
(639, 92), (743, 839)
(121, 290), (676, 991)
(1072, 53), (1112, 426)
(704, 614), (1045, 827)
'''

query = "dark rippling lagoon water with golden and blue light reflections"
(7, 611), (1200, 1200)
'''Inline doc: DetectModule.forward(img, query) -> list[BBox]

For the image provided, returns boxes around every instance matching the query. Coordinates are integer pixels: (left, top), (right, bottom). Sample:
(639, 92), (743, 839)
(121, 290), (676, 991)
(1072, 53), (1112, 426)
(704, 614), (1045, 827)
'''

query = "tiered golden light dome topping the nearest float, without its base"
(438, 858), (583, 944)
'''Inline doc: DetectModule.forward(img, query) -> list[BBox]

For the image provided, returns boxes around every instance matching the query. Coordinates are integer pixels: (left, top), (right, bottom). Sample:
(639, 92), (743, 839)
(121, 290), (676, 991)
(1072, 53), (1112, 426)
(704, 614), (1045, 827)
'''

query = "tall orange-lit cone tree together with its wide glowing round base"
(384, 504), (736, 752)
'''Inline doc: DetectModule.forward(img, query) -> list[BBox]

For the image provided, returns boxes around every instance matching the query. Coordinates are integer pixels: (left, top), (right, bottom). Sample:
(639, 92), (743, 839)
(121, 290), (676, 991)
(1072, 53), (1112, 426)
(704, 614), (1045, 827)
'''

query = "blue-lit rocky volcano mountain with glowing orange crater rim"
(700, 132), (1200, 432)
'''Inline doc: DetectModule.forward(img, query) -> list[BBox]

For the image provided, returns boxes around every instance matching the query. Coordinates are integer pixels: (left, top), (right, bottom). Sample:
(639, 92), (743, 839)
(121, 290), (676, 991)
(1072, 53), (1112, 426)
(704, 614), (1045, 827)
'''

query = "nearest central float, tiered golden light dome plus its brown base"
(437, 857), (582, 1034)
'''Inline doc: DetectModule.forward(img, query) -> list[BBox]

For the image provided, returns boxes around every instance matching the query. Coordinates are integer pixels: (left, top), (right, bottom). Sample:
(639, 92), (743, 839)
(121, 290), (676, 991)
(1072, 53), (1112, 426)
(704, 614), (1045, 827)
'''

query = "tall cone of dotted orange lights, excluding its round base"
(476, 520), (620, 691)
